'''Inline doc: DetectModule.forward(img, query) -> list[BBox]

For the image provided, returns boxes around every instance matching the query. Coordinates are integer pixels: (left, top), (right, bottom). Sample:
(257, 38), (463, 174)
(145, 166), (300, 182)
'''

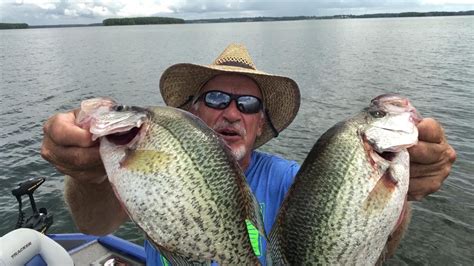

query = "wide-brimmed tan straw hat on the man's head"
(160, 44), (300, 148)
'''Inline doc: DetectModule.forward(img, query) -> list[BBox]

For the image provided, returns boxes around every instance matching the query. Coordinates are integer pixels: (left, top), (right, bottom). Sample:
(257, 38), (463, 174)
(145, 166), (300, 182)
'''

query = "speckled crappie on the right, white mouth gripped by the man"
(267, 95), (421, 265)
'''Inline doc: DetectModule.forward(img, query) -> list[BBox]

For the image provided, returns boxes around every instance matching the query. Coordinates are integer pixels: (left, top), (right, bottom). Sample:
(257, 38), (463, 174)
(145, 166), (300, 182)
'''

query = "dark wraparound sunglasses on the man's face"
(198, 90), (263, 114)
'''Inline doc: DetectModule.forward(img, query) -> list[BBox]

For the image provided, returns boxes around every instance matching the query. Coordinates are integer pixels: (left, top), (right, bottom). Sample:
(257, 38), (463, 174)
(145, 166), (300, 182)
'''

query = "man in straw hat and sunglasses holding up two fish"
(41, 44), (456, 264)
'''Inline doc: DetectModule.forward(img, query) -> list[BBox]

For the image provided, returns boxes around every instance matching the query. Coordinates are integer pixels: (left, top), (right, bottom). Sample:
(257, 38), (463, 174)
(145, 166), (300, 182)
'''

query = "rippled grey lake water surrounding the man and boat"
(0, 16), (474, 265)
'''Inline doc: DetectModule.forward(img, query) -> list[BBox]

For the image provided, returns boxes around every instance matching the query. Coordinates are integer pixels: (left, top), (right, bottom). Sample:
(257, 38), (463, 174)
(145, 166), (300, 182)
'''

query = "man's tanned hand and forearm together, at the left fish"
(41, 110), (128, 235)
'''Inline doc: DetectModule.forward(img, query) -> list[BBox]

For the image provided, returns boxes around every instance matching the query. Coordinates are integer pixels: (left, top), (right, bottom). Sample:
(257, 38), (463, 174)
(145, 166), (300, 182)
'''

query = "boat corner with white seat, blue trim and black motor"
(0, 177), (146, 266)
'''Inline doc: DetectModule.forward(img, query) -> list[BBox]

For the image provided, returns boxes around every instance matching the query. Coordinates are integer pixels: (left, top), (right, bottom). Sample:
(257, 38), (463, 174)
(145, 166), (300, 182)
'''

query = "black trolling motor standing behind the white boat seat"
(12, 177), (53, 233)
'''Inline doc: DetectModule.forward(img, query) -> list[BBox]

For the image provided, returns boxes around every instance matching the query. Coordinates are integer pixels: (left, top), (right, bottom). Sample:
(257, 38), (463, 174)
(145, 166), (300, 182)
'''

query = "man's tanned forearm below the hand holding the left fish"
(64, 176), (128, 235)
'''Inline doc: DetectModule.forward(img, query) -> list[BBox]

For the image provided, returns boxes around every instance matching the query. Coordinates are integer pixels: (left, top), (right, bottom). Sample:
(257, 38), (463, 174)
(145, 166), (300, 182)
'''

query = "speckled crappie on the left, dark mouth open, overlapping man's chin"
(76, 98), (264, 265)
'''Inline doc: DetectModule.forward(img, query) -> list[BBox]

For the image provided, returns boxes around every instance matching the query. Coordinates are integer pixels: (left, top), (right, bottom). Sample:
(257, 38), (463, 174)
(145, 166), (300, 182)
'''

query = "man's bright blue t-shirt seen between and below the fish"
(145, 151), (300, 265)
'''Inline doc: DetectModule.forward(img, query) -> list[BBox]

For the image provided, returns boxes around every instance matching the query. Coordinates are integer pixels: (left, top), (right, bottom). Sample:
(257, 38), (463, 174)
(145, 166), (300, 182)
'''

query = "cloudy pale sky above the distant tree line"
(0, 0), (474, 25)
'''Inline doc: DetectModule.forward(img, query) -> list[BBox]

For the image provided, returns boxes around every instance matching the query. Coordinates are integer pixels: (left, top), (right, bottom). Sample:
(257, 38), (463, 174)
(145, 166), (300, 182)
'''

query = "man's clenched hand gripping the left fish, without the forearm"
(41, 110), (106, 183)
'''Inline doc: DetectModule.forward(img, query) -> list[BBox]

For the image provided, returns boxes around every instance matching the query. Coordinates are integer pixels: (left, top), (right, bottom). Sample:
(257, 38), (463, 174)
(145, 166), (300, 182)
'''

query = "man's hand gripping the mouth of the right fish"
(408, 118), (456, 200)
